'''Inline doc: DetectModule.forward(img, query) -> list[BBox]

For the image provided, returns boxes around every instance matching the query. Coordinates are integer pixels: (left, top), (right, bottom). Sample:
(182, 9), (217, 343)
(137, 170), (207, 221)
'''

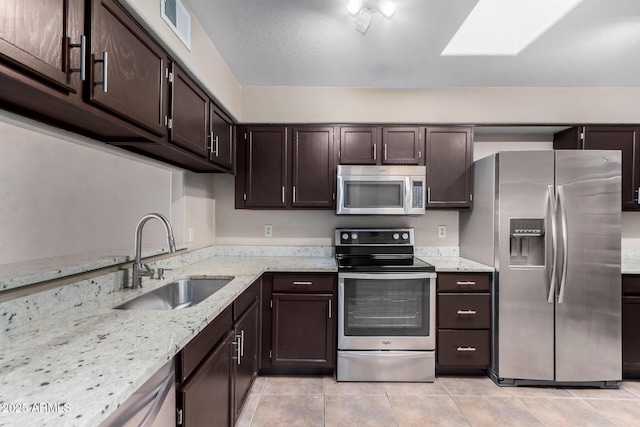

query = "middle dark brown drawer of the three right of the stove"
(438, 294), (491, 329)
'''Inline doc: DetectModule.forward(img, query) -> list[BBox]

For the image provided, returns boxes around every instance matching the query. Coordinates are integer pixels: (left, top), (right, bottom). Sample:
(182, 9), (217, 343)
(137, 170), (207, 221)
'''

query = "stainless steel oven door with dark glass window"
(338, 272), (436, 350)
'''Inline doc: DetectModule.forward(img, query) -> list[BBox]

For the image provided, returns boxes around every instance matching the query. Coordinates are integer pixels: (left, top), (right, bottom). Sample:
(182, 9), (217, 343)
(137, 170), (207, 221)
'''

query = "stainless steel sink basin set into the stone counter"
(115, 277), (233, 310)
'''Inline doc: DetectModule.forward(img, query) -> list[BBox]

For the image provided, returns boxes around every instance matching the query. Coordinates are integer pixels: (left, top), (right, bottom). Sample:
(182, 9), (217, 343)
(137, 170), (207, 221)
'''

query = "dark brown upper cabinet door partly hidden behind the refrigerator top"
(584, 126), (640, 210)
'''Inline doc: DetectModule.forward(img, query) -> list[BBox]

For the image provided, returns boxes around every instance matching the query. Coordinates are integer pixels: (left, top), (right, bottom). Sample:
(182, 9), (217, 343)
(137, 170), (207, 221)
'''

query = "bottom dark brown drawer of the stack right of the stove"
(436, 330), (491, 368)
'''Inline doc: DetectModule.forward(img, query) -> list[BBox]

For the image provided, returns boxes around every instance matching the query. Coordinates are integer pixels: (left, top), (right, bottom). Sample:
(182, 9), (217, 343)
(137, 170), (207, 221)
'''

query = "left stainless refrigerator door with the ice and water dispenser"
(494, 150), (554, 380)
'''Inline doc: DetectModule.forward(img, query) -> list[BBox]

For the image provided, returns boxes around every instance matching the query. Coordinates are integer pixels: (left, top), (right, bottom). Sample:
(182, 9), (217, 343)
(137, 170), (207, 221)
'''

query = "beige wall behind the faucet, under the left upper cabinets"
(0, 111), (214, 264)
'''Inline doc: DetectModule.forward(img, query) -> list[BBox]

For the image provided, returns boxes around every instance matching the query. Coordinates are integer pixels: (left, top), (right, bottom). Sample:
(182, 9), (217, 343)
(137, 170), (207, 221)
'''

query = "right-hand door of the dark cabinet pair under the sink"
(233, 301), (260, 422)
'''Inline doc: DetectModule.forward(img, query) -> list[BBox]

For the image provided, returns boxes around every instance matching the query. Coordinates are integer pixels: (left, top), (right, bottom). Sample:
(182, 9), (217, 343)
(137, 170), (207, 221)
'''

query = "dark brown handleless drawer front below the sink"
(178, 306), (232, 381)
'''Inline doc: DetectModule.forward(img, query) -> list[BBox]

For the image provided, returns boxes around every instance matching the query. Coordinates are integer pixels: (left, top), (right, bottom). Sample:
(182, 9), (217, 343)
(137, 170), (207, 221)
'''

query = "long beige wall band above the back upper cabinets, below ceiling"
(242, 86), (640, 124)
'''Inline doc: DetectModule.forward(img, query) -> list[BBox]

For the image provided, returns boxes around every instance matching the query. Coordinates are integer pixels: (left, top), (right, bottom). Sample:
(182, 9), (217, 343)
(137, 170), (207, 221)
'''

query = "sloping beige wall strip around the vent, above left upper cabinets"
(120, 0), (241, 120)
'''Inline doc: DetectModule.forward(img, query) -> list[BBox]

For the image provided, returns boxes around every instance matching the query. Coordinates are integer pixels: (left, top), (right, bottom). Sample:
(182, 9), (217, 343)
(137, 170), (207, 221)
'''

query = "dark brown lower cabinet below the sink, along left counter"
(176, 280), (261, 427)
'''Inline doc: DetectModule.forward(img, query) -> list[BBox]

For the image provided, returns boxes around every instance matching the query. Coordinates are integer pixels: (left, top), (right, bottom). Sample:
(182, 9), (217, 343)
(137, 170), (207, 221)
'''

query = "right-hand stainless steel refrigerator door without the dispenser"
(556, 150), (622, 382)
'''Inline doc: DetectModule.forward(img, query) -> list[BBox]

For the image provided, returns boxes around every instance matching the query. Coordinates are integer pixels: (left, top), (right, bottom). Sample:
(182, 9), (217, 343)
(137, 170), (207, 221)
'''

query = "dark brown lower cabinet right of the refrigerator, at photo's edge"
(622, 274), (640, 378)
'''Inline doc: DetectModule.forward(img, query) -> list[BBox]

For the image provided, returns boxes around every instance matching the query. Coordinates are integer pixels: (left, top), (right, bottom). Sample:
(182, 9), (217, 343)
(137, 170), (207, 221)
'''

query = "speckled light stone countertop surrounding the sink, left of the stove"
(0, 256), (336, 427)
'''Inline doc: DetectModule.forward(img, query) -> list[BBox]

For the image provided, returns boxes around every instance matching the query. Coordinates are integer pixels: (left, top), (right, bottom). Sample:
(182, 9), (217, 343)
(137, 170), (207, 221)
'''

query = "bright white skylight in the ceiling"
(441, 0), (583, 56)
